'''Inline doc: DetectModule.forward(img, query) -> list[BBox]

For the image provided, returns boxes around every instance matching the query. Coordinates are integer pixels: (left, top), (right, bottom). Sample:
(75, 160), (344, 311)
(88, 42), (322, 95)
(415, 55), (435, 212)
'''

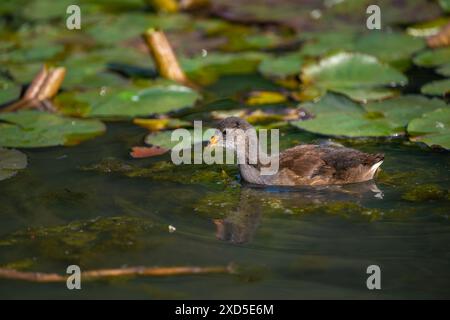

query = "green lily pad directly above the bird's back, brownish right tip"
(291, 94), (403, 138)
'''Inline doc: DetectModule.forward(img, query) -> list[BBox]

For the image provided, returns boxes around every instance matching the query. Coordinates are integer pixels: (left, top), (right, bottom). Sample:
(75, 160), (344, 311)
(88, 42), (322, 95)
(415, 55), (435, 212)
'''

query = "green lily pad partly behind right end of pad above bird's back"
(364, 95), (446, 127)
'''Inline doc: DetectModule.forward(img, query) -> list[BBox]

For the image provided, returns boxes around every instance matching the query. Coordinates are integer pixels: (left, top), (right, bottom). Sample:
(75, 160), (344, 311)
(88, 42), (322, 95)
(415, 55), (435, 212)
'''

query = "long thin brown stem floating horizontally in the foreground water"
(0, 265), (235, 282)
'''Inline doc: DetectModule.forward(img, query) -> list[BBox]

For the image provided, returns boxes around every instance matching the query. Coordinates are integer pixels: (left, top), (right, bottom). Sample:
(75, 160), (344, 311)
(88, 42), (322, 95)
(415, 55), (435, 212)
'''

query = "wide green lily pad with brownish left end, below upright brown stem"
(55, 84), (200, 118)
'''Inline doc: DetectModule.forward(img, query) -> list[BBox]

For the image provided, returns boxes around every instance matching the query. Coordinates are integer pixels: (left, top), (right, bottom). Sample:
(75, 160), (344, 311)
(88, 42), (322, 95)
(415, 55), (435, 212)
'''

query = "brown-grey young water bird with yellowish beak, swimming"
(208, 117), (384, 186)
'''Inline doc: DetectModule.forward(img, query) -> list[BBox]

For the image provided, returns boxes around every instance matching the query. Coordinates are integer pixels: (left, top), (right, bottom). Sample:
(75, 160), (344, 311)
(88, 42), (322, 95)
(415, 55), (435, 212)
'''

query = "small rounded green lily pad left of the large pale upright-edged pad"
(258, 53), (303, 78)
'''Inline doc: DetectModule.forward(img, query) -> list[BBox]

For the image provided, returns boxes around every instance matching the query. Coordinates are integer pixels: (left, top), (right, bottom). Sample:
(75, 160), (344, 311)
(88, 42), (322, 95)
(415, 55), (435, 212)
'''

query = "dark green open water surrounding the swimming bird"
(0, 75), (450, 299)
